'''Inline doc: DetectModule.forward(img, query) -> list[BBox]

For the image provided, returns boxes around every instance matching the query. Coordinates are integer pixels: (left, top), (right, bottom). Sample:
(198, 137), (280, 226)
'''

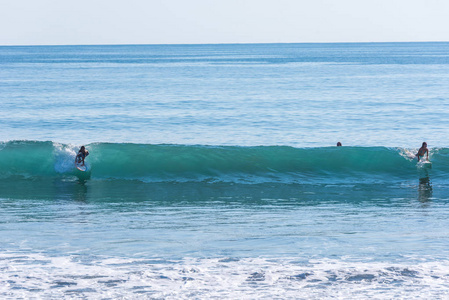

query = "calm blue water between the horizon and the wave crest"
(0, 43), (449, 147)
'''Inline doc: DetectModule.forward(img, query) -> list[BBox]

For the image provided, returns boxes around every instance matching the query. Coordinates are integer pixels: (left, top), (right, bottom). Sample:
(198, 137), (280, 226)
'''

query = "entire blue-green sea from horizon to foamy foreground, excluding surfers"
(0, 43), (449, 299)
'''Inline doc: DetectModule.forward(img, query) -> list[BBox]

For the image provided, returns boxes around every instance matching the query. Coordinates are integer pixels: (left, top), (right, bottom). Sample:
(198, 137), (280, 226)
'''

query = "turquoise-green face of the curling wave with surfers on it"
(0, 141), (449, 184)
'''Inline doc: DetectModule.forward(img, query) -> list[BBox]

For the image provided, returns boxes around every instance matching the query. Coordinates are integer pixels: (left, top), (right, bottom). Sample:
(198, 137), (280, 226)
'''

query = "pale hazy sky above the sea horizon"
(0, 0), (449, 45)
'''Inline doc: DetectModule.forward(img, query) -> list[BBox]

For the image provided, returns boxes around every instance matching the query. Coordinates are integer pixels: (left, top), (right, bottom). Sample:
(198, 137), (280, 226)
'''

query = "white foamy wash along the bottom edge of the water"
(0, 253), (449, 299)
